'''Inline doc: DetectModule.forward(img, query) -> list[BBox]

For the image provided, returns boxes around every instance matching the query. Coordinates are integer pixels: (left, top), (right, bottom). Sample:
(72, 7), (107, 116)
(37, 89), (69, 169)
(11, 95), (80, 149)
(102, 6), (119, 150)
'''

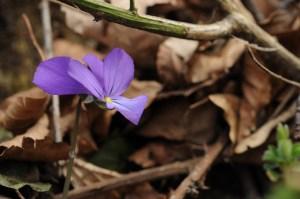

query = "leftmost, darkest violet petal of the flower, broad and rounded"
(33, 57), (89, 95)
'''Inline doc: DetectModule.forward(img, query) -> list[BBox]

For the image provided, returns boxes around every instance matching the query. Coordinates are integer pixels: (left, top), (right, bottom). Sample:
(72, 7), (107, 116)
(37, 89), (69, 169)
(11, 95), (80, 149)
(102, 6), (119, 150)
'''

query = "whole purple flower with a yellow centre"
(33, 48), (147, 124)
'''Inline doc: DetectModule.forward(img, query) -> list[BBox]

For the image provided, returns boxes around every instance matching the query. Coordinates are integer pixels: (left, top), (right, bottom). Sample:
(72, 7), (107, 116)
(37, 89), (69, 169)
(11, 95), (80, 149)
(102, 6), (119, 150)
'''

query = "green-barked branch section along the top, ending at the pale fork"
(62, 0), (234, 40)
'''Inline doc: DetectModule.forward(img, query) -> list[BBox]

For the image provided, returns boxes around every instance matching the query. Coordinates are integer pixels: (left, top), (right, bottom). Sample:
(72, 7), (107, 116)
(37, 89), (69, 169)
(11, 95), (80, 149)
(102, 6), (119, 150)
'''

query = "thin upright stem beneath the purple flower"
(62, 98), (81, 199)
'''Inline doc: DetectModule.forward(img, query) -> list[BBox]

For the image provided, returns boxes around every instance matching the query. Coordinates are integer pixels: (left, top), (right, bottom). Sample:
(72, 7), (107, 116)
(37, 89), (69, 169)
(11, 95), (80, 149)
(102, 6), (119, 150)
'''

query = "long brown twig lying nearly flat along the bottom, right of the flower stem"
(56, 158), (201, 199)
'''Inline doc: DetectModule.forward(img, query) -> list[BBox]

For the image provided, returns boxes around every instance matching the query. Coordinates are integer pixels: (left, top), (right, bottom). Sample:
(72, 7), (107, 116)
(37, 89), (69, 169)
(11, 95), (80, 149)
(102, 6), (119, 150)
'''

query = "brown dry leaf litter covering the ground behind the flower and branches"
(0, 0), (300, 199)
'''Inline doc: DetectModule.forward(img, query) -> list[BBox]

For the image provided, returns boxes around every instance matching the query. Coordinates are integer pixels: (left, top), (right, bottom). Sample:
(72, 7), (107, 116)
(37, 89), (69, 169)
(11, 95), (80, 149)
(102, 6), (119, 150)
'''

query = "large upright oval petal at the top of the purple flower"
(103, 48), (134, 97)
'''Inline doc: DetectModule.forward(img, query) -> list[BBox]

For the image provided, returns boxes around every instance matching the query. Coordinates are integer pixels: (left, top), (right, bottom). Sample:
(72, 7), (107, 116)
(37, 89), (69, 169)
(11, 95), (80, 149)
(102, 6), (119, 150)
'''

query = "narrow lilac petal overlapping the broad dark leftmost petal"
(68, 59), (103, 100)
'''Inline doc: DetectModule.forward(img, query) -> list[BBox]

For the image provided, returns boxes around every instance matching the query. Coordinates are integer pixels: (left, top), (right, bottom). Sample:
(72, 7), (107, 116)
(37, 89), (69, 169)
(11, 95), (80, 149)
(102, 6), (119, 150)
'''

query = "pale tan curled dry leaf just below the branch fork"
(186, 39), (245, 83)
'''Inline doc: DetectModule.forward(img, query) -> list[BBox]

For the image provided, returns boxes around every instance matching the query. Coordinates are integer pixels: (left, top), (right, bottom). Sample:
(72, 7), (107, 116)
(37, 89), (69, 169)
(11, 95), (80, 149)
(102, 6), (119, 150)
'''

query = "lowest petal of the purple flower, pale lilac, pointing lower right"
(112, 95), (147, 125)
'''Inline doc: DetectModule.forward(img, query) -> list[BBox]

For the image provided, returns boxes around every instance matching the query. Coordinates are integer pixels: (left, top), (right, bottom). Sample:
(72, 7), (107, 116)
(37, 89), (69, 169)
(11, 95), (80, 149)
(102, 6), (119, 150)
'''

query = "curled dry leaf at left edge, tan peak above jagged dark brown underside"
(0, 115), (69, 161)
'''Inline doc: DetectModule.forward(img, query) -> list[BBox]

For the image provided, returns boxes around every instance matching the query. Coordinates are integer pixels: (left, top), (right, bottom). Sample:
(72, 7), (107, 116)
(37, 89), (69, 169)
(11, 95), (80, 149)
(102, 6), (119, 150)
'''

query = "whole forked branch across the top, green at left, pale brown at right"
(61, 0), (300, 82)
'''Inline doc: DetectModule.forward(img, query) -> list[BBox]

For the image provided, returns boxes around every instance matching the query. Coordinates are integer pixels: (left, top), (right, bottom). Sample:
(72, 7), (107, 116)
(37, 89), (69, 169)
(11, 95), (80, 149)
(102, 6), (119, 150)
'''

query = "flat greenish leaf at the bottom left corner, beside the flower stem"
(0, 174), (51, 192)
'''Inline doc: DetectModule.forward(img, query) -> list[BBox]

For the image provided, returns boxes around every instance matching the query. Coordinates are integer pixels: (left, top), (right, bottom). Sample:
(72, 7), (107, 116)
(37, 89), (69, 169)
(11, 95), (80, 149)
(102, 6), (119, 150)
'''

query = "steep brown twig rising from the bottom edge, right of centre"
(170, 136), (227, 199)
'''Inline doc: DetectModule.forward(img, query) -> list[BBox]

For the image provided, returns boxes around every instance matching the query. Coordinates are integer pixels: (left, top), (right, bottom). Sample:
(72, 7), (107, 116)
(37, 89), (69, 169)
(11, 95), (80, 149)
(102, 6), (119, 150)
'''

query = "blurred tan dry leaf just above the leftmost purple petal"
(53, 39), (104, 60)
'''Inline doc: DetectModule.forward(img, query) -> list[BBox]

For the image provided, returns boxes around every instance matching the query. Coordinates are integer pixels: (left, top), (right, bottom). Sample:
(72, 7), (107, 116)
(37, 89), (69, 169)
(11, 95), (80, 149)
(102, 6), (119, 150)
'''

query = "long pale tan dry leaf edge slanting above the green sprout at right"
(235, 104), (296, 153)
